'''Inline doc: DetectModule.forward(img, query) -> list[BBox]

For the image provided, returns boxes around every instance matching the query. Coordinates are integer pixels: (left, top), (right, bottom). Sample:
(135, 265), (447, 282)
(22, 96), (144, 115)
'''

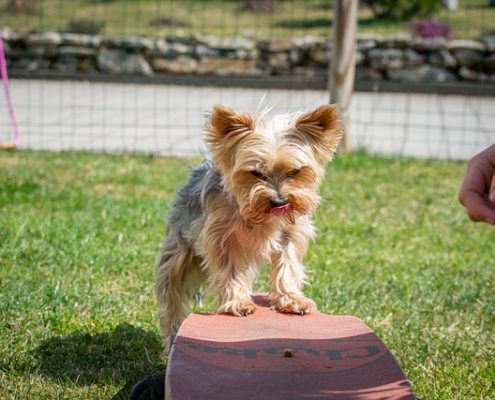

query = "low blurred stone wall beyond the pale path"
(3, 31), (495, 83)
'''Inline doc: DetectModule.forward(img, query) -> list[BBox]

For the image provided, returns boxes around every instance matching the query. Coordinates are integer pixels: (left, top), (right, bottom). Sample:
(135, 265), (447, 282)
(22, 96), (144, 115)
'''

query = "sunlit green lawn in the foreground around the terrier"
(0, 148), (495, 400)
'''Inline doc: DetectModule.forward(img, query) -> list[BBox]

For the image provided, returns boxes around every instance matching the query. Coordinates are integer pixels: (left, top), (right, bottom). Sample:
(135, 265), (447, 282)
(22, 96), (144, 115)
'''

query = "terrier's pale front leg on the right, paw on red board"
(270, 242), (316, 314)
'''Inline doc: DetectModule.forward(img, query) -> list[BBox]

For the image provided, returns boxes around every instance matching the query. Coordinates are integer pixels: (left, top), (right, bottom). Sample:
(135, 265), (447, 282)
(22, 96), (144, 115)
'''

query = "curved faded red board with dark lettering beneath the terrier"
(165, 296), (415, 400)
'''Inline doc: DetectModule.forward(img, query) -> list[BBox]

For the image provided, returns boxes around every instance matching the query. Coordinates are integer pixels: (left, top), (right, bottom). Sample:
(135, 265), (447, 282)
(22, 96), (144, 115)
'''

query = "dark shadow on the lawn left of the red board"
(35, 324), (164, 399)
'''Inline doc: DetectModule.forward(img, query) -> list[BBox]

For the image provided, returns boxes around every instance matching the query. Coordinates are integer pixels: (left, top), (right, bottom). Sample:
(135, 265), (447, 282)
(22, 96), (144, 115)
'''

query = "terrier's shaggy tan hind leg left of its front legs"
(155, 236), (206, 354)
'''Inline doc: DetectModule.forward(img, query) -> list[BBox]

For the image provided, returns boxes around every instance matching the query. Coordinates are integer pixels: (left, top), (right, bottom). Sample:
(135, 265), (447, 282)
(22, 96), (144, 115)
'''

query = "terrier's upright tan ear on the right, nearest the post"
(295, 104), (344, 165)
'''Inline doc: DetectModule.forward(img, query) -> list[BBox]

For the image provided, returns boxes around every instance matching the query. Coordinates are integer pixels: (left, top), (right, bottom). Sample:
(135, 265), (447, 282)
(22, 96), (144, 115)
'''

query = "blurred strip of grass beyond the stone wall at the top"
(0, 0), (495, 38)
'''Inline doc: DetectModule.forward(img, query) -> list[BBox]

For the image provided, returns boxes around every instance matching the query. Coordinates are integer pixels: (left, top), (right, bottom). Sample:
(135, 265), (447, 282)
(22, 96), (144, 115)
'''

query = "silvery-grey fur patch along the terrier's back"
(168, 159), (223, 244)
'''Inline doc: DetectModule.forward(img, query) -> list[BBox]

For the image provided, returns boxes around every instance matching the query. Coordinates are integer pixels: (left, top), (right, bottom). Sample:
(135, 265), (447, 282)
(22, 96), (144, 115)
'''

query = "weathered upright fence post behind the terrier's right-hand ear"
(329, 0), (358, 153)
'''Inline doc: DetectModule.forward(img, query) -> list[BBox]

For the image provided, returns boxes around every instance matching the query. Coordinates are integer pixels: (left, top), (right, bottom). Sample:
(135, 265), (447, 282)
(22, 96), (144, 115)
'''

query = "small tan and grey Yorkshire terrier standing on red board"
(156, 105), (343, 351)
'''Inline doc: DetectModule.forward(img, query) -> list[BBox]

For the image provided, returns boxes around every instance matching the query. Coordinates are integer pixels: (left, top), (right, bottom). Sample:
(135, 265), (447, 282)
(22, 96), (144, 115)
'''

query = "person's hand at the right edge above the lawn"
(459, 144), (495, 225)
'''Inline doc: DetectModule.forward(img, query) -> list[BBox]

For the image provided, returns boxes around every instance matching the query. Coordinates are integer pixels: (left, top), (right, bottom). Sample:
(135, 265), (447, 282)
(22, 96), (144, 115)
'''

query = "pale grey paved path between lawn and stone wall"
(0, 80), (495, 159)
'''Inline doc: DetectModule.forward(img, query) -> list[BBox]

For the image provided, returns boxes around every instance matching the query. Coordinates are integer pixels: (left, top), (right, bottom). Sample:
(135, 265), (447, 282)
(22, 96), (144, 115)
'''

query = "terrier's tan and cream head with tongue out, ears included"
(206, 105), (343, 224)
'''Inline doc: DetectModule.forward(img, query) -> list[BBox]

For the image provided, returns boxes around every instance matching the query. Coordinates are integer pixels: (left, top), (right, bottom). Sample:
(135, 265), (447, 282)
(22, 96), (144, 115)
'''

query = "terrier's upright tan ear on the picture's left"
(206, 105), (255, 172)
